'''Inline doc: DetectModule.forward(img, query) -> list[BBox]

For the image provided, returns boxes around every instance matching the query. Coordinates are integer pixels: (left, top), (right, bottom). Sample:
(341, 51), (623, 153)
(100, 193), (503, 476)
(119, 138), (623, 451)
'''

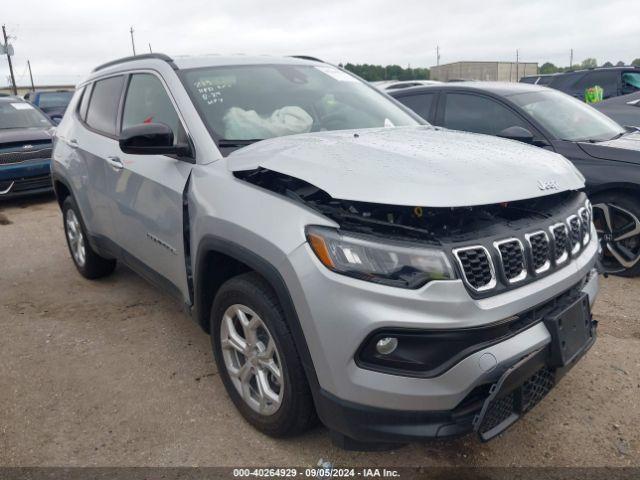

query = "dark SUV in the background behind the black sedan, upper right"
(520, 67), (640, 101)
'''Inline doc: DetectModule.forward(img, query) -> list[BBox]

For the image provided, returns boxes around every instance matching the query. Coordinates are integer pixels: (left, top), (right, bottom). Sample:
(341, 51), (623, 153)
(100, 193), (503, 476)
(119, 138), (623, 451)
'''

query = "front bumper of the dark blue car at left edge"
(0, 159), (53, 199)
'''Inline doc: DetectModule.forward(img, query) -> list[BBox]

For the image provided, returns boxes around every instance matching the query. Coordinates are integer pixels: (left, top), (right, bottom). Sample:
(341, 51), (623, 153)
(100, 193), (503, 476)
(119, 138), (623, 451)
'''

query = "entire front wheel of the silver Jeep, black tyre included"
(211, 273), (316, 437)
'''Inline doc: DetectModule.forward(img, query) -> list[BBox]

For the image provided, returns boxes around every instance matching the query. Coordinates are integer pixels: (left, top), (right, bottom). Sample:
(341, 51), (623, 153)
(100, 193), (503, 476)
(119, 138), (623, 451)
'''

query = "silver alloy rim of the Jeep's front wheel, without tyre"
(220, 304), (284, 416)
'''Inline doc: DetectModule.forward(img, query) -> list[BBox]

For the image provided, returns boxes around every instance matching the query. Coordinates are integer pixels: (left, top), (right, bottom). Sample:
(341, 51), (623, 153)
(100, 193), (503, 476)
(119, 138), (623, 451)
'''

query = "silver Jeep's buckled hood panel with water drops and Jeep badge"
(228, 126), (584, 207)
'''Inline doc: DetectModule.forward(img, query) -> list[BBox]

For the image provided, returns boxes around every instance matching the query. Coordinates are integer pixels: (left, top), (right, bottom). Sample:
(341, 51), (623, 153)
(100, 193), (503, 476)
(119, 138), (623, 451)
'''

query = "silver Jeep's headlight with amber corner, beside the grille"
(307, 227), (456, 288)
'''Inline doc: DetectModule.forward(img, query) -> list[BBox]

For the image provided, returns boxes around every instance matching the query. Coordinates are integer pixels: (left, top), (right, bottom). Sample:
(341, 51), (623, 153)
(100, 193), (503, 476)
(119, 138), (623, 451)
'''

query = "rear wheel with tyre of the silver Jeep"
(62, 195), (116, 280)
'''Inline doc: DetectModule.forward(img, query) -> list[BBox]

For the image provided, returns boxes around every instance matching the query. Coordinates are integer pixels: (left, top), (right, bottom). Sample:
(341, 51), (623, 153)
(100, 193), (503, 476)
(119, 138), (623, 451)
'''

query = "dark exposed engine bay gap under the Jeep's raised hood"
(234, 168), (578, 244)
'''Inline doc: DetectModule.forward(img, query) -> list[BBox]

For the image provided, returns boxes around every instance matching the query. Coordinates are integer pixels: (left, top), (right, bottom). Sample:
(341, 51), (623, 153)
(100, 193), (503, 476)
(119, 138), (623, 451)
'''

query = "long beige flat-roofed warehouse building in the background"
(431, 62), (538, 82)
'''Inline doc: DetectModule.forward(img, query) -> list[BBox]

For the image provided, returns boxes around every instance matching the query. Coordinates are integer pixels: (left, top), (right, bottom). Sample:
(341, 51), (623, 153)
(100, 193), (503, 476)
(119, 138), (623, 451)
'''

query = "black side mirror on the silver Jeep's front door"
(118, 123), (191, 157)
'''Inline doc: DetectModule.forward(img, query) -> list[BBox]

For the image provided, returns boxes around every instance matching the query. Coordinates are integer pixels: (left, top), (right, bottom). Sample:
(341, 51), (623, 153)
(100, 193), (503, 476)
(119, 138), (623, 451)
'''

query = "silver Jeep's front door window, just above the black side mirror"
(122, 73), (186, 143)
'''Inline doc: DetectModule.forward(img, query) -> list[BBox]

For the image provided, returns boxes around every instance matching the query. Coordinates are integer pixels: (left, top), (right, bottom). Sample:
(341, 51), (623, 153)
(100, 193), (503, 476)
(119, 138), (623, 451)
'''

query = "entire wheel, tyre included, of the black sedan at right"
(591, 193), (640, 277)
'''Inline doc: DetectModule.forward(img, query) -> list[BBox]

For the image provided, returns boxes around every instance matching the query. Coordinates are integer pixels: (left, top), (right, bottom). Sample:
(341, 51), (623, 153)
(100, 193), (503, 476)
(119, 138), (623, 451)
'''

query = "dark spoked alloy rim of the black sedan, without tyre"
(593, 203), (640, 273)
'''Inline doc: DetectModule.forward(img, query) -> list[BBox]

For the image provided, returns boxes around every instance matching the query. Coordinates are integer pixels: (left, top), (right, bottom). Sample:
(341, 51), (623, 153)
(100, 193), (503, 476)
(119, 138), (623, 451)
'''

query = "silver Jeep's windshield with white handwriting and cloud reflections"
(182, 64), (420, 146)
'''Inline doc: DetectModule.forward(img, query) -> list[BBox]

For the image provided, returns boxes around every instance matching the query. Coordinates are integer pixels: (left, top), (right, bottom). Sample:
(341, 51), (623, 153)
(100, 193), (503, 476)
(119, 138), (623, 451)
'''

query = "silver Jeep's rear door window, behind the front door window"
(81, 75), (124, 137)
